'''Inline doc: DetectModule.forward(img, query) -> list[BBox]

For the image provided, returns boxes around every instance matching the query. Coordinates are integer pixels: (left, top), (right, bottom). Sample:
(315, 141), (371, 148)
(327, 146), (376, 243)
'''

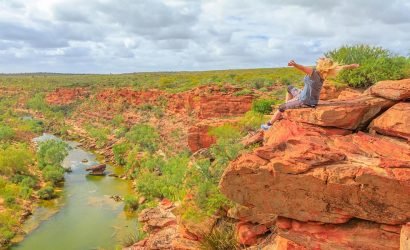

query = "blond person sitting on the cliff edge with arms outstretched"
(261, 57), (359, 130)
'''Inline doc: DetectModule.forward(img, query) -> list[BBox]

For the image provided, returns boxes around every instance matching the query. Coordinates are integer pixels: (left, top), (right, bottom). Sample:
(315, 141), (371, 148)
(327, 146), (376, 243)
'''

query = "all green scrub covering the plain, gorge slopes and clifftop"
(0, 45), (410, 249)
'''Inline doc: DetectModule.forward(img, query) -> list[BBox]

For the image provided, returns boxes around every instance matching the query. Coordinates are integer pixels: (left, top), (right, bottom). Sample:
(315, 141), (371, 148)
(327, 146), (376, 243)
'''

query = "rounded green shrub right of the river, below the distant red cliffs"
(125, 124), (160, 152)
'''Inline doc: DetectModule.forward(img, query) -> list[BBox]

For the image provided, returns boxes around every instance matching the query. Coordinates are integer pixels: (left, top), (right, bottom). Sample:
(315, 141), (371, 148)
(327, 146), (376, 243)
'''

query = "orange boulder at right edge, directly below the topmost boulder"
(370, 102), (410, 140)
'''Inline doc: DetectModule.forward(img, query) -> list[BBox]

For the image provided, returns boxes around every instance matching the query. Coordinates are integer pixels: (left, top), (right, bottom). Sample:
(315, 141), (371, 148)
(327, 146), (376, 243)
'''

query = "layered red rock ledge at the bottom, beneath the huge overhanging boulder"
(277, 217), (400, 250)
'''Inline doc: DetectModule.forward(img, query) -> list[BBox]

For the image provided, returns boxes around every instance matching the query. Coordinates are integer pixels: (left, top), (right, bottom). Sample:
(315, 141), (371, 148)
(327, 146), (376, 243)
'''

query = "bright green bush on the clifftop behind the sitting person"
(325, 44), (410, 88)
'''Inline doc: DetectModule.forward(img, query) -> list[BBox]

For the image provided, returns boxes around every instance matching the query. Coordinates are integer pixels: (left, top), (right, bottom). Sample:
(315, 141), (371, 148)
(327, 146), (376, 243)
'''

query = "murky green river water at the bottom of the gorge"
(11, 134), (137, 250)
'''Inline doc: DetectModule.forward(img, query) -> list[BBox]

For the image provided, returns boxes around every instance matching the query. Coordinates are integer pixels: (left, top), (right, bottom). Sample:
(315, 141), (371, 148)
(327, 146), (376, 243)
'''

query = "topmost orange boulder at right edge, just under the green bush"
(366, 78), (410, 101)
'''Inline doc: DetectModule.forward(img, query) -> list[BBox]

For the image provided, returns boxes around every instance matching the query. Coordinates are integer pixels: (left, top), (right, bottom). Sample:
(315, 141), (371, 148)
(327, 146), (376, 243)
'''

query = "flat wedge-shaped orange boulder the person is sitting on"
(284, 95), (395, 130)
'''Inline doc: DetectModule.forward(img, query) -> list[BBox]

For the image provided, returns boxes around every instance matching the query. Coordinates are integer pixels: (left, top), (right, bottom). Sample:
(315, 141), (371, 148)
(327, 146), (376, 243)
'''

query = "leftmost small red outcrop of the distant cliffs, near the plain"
(46, 88), (88, 105)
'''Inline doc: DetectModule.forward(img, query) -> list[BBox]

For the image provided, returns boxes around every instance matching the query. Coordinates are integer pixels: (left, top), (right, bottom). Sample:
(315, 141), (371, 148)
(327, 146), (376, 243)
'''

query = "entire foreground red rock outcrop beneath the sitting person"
(220, 79), (410, 249)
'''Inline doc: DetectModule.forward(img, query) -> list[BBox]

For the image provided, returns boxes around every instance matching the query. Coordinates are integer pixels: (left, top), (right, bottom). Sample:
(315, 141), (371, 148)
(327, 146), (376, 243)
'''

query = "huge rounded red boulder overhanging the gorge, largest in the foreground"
(220, 129), (410, 224)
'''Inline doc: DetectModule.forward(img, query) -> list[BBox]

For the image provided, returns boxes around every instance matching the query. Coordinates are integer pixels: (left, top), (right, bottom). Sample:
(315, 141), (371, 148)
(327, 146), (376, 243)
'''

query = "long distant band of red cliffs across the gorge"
(46, 86), (257, 152)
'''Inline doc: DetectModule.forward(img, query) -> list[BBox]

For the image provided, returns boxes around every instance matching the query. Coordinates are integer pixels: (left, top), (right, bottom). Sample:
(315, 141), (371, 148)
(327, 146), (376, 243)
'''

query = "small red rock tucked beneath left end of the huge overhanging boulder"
(236, 222), (269, 246)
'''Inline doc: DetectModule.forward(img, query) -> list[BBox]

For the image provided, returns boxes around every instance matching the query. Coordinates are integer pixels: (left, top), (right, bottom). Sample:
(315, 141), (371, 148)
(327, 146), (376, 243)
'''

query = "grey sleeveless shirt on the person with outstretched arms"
(299, 69), (323, 105)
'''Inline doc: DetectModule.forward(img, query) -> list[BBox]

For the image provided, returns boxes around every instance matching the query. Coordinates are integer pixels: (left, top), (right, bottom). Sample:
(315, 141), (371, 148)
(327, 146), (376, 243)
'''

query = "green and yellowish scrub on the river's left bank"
(0, 96), (66, 246)
